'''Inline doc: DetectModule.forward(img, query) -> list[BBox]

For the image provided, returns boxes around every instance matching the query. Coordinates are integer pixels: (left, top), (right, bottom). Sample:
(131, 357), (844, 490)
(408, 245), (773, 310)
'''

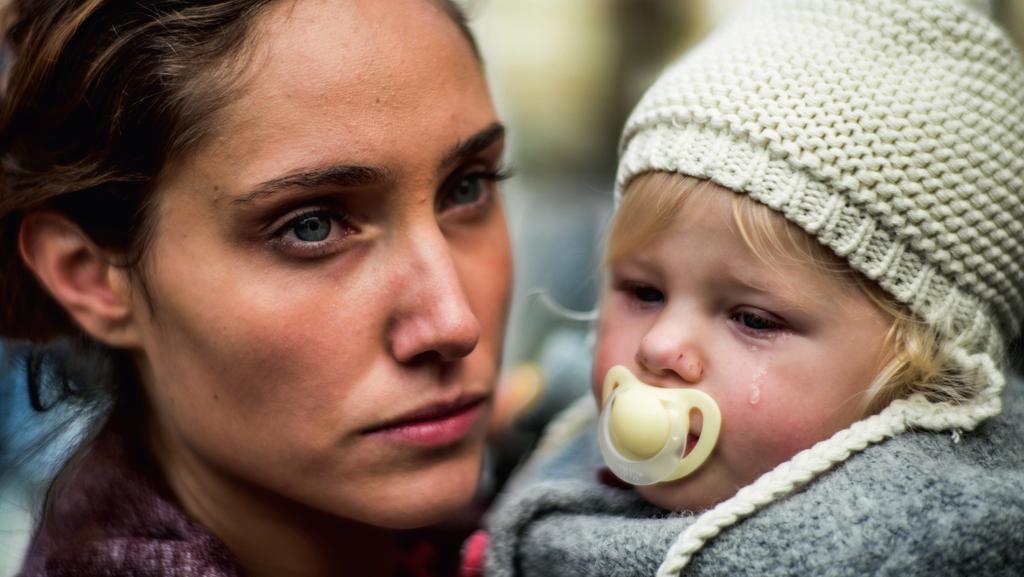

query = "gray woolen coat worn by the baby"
(485, 378), (1024, 577)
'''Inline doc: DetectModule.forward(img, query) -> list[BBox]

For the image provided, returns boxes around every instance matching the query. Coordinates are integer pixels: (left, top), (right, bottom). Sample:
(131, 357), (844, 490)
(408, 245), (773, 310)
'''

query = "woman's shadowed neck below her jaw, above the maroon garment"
(151, 420), (399, 577)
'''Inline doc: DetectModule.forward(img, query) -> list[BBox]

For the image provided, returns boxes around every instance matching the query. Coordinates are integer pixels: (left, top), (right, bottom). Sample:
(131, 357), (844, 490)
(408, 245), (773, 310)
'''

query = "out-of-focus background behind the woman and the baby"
(0, 0), (1024, 577)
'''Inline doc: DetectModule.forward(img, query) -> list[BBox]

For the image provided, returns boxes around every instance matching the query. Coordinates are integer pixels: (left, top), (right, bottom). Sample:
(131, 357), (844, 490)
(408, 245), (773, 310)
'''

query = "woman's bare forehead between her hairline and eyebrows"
(167, 0), (497, 200)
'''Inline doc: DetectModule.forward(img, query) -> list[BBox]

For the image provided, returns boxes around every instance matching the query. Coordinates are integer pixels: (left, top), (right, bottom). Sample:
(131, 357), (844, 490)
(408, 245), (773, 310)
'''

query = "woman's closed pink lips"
(366, 396), (486, 447)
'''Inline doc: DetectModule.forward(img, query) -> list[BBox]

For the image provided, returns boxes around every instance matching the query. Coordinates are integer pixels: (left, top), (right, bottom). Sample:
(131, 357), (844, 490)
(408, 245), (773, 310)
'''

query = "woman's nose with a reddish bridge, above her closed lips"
(389, 229), (480, 363)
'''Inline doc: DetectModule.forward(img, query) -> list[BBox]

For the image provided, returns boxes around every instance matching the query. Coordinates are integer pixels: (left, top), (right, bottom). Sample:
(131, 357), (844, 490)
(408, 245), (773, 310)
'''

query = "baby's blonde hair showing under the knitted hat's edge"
(604, 172), (976, 414)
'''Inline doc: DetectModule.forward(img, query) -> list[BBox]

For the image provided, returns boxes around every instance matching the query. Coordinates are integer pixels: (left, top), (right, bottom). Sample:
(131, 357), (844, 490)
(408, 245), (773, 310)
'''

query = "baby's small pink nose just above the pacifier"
(636, 320), (705, 384)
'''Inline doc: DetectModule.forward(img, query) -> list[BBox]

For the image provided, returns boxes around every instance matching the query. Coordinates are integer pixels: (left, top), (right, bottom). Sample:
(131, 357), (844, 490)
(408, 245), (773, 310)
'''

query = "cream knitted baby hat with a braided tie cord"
(616, 0), (1024, 575)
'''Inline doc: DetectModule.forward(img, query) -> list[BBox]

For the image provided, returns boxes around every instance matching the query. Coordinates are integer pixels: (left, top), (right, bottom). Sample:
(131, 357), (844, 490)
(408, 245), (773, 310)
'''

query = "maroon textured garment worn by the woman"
(17, 428), (475, 577)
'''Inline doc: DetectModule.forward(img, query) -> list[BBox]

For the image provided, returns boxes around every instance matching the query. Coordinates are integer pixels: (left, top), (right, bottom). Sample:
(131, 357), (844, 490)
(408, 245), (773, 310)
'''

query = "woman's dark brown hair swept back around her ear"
(0, 0), (280, 341)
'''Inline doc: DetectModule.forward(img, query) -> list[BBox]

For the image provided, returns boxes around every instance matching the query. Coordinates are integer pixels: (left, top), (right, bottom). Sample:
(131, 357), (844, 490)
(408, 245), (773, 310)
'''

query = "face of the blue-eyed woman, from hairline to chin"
(134, 0), (511, 528)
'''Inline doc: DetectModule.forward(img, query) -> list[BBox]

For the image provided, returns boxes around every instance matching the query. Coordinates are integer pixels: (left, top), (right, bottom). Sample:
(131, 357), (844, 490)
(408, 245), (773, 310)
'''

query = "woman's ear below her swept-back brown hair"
(18, 211), (139, 348)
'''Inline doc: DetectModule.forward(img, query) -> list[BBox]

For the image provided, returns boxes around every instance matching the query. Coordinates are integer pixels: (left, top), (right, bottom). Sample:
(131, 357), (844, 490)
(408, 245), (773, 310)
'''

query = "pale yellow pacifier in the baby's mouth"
(598, 365), (722, 485)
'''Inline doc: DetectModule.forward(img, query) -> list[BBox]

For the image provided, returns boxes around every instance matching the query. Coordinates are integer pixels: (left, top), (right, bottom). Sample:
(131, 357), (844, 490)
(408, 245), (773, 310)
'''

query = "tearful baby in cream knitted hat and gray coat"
(486, 0), (1024, 577)
